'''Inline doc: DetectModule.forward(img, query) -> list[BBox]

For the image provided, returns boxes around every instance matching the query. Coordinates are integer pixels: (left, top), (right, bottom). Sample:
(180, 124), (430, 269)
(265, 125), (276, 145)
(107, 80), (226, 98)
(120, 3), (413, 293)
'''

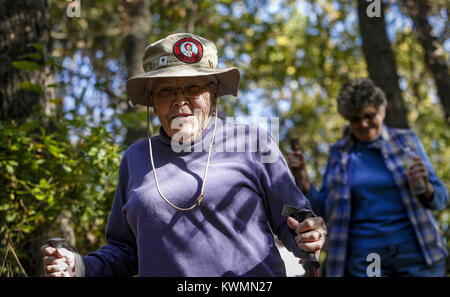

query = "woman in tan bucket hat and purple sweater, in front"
(42, 33), (326, 276)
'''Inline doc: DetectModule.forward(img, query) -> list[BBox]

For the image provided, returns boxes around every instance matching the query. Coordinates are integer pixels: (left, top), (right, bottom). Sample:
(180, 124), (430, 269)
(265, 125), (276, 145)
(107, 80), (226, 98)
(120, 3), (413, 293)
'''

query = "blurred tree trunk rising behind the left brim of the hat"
(124, 0), (151, 145)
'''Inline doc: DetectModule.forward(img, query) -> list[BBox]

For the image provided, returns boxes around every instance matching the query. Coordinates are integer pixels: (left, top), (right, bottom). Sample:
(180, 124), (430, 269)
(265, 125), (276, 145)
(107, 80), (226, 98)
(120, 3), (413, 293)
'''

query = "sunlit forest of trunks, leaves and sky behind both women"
(0, 0), (450, 276)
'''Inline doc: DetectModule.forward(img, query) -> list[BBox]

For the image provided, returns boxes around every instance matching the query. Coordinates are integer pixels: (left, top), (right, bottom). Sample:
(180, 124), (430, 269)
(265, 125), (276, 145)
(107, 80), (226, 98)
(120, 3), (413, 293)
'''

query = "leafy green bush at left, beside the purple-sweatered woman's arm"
(0, 117), (120, 250)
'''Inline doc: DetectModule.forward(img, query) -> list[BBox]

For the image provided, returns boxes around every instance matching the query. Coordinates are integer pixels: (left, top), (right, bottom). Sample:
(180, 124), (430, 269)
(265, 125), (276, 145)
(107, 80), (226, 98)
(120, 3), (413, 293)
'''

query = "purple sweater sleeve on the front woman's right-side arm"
(256, 129), (311, 257)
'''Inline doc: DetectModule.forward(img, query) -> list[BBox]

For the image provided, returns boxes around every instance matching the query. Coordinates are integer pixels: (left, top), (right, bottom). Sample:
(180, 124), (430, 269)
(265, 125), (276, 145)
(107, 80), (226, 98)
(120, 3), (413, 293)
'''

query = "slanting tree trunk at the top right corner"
(400, 0), (450, 125)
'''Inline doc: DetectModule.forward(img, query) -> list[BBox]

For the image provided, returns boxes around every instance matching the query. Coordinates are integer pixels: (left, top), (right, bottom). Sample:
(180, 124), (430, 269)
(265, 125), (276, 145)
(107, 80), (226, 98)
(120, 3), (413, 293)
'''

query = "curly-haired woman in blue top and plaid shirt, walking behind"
(288, 79), (448, 276)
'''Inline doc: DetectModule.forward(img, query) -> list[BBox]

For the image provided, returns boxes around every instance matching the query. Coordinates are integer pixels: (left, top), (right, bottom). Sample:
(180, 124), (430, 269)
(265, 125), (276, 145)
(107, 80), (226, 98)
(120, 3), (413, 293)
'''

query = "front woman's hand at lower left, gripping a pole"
(41, 244), (75, 277)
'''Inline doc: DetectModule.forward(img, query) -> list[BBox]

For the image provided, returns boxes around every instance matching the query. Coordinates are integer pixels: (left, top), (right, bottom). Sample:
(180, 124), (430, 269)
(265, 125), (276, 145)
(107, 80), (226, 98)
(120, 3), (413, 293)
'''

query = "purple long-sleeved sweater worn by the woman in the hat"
(82, 120), (310, 276)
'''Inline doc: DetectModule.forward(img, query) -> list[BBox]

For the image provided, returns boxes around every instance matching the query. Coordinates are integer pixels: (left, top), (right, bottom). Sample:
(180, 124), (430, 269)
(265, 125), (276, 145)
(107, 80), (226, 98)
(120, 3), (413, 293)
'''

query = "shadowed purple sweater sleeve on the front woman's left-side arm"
(82, 154), (138, 276)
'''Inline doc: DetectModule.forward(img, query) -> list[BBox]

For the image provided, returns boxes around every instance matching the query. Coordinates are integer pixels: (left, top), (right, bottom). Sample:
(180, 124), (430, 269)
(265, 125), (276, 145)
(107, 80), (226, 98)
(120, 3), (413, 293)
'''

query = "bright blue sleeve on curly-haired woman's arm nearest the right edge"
(414, 134), (448, 210)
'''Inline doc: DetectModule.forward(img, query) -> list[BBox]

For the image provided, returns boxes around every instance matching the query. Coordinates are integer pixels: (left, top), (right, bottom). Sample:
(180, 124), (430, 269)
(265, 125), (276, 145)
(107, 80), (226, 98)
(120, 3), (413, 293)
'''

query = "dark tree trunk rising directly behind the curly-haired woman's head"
(358, 0), (408, 129)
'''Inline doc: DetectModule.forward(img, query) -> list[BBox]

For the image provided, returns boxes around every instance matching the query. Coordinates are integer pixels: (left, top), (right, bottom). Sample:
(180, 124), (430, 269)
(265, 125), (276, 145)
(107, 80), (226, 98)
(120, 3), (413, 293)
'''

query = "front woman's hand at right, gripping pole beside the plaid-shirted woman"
(287, 217), (327, 259)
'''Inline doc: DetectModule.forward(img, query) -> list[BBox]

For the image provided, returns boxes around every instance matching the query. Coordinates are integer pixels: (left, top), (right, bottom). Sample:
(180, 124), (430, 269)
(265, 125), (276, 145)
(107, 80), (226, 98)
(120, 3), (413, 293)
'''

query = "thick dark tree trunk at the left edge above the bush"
(0, 0), (54, 121)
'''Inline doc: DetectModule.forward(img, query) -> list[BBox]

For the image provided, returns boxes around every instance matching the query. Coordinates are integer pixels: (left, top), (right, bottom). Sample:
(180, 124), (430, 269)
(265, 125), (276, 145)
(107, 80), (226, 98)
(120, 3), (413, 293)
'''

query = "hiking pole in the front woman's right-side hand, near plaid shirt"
(281, 204), (320, 277)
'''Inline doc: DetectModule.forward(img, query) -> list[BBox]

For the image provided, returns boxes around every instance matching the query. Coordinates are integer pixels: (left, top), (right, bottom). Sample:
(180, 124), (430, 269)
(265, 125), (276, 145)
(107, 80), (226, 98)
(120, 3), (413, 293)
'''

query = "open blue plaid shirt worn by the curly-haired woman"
(306, 126), (448, 276)
